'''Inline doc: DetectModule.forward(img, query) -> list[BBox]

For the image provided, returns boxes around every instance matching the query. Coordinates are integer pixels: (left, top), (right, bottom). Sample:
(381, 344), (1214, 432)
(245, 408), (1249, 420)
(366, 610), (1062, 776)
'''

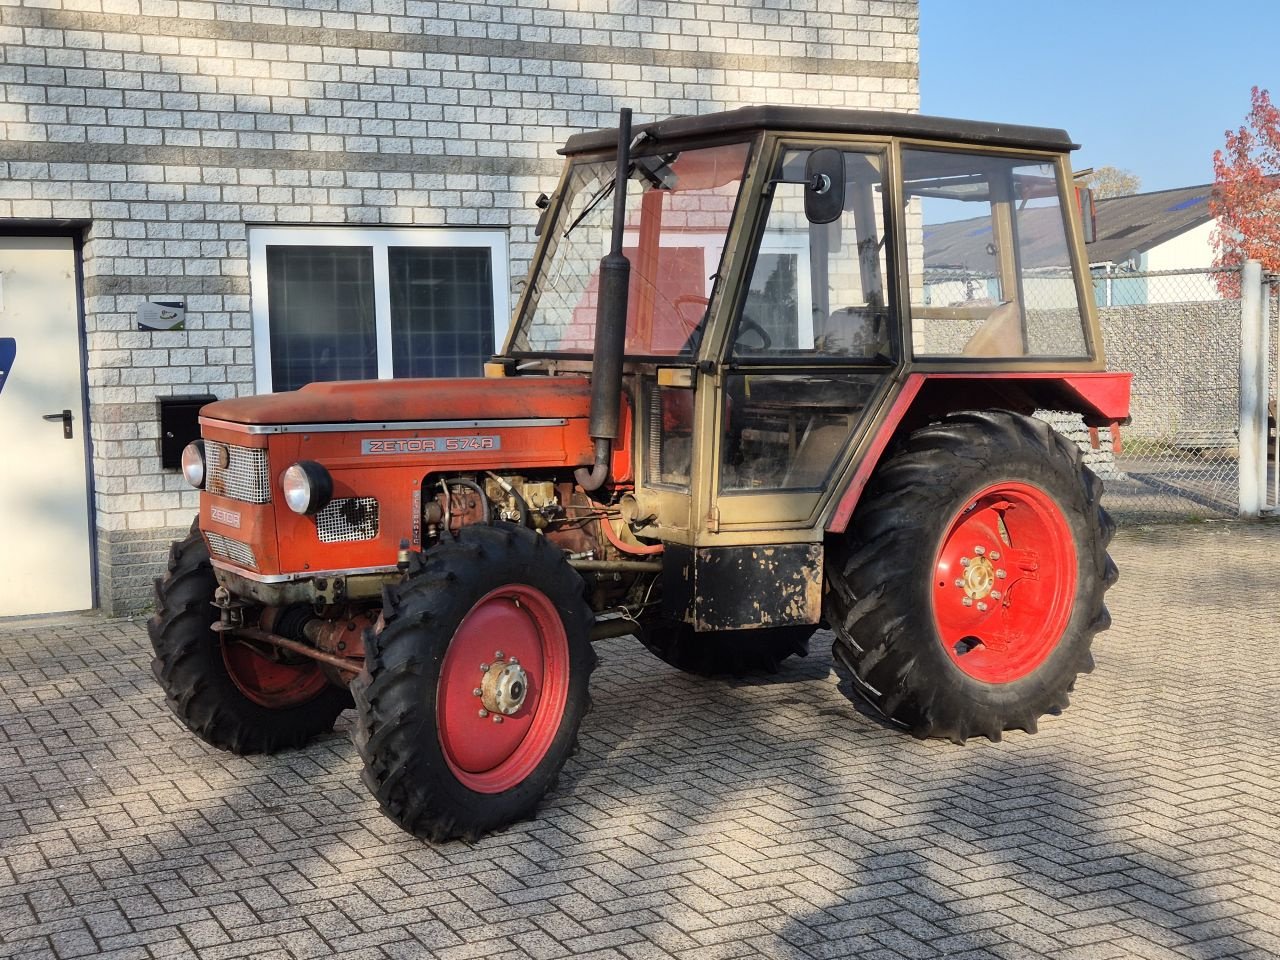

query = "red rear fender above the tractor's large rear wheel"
(826, 372), (1133, 534)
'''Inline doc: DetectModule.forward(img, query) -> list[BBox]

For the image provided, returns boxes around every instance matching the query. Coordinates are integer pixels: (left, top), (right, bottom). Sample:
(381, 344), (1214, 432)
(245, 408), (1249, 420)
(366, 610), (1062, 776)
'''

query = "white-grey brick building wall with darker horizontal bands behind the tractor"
(0, 0), (919, 608)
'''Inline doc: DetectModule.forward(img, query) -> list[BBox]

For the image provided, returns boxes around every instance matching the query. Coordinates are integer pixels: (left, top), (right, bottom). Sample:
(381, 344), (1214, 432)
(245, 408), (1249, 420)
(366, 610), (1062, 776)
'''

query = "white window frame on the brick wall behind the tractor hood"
(248, 224), (511, 393)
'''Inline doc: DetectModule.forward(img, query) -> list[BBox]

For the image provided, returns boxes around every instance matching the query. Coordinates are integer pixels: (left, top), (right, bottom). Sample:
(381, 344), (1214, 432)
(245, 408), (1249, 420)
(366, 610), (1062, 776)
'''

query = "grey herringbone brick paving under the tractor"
(0, 524), (1280, 960)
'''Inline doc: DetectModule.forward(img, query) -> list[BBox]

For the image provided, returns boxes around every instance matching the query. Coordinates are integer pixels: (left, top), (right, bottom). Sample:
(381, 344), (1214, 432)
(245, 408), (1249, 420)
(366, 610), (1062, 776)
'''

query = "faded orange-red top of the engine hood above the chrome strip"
(200, 376), (591, 426)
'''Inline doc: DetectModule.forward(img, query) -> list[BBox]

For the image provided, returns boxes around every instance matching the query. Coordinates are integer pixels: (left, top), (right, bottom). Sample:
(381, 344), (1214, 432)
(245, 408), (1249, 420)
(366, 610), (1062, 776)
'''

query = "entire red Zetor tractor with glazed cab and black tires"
(150, 108), (1128, 840)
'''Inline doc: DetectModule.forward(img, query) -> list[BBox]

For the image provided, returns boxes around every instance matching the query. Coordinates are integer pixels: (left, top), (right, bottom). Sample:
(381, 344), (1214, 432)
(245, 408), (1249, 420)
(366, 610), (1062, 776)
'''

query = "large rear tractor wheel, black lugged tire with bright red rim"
(827, 412), (1116, 744)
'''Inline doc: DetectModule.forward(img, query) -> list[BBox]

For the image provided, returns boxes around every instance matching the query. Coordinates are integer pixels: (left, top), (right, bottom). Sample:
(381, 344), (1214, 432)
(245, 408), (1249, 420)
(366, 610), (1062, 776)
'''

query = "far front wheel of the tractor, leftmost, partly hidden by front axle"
(147, 524), (351, 754)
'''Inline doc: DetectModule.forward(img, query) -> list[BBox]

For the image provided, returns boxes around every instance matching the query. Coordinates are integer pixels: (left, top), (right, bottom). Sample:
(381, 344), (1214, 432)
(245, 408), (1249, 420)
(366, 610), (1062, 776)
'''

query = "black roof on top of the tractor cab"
(559, 106), (1079, 155)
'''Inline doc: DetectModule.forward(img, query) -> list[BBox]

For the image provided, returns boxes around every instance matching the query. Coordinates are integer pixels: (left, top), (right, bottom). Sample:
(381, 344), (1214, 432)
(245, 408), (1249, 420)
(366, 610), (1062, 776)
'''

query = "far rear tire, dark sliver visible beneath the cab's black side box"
(640, 621), (818, 677)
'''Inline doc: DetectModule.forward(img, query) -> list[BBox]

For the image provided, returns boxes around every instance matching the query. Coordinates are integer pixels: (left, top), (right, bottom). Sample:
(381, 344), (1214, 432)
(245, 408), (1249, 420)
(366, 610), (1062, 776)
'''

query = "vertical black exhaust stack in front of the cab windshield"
(573, 108), (631, 490)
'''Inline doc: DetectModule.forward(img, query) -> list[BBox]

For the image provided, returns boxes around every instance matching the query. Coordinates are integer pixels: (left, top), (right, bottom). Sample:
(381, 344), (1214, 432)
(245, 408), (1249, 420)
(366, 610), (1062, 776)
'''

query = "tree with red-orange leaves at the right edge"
(1210, 87), (1280, 296)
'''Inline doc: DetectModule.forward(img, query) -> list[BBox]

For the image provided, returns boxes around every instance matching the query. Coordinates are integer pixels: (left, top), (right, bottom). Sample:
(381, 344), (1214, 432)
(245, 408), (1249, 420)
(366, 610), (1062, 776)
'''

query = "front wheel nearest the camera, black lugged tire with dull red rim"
(352, 524), (595, 841)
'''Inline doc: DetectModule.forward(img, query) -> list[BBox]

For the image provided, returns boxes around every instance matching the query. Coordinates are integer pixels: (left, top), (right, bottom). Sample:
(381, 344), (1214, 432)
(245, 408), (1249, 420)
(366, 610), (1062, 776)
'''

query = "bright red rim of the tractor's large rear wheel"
(932, 481), (1076, 684)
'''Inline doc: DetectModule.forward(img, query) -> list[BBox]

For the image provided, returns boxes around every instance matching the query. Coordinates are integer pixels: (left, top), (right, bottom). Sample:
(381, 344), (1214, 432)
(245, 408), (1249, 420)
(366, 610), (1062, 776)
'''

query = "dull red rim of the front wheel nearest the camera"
(435, 584), (568, 794)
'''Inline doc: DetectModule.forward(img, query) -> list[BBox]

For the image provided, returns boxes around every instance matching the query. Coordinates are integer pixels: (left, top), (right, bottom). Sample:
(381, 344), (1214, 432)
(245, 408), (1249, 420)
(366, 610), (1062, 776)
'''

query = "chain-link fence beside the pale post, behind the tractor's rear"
(1044, 264), (1280, 522)
